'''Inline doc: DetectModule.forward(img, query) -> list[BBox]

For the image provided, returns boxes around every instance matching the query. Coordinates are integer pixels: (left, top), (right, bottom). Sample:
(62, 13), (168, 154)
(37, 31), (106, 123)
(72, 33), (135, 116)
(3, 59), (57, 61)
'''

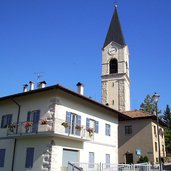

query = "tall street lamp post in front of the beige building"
(152, 93), (161, 171)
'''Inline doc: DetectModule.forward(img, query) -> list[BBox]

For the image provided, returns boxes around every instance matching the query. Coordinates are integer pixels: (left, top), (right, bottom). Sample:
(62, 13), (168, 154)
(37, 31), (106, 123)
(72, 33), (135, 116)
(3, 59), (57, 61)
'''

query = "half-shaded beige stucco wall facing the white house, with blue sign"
(119, 119), (153, 163)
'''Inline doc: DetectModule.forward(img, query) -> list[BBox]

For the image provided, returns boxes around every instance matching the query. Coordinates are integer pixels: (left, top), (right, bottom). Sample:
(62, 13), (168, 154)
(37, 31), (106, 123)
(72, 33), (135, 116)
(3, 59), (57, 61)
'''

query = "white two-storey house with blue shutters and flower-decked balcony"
(0, 82), (125, 171)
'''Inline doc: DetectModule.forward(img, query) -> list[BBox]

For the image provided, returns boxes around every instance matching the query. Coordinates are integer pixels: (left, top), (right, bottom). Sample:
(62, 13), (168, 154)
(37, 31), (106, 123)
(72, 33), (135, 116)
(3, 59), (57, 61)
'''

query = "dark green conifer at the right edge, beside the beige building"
(162, 105), (171, 155)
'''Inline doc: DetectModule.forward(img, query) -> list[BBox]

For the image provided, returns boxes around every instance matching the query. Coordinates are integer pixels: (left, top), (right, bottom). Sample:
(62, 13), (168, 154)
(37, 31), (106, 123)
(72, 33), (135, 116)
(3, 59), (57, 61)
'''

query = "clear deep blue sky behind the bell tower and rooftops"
(0, 0), (171, 111)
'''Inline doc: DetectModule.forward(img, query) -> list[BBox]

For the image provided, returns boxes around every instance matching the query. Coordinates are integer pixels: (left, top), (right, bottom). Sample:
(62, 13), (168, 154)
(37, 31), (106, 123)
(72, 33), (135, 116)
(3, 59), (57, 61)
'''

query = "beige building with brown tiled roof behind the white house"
(118, 110), (166, 163)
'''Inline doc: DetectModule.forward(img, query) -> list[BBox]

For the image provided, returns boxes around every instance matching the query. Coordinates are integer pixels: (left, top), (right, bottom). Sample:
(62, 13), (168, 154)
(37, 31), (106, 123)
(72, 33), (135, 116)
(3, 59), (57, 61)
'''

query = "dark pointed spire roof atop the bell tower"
(103, 6), (126, 48)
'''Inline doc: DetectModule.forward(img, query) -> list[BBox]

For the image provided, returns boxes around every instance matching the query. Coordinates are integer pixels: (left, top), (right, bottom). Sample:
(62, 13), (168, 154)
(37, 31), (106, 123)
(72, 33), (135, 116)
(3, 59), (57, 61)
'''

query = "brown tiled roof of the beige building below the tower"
(123, 110), (167, 127)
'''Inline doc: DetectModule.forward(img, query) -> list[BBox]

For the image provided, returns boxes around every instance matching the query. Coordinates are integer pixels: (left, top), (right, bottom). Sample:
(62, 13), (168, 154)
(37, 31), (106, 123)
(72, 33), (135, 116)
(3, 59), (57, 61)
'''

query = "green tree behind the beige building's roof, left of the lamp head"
(140, 94), (161, 114)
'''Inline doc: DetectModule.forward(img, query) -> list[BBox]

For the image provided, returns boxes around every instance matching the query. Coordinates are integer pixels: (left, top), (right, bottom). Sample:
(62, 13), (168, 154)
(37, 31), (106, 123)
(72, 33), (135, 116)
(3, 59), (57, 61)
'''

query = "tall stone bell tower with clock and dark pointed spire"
(102, 5), (130, 112)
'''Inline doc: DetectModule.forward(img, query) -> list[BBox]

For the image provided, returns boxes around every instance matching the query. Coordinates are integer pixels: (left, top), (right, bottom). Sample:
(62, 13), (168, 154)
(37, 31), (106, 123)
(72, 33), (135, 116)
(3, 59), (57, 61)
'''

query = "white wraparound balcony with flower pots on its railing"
(7, 119), (94, 141)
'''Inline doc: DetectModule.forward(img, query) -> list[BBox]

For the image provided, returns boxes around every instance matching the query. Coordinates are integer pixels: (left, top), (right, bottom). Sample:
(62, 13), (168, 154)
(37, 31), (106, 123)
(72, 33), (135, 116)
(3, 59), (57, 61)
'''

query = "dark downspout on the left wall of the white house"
(11, 99), (21, 171)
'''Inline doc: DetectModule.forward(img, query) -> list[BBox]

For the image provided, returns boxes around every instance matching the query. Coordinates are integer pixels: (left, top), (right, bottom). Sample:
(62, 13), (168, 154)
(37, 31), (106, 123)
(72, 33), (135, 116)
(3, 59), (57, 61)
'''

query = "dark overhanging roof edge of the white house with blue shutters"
(0, 84), (129, 120)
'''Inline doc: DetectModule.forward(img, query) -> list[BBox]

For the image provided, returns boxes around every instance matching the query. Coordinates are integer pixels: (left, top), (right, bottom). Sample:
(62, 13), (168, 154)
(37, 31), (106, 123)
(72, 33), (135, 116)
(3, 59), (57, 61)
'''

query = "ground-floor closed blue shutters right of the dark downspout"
(25, 148), (34, 168)
